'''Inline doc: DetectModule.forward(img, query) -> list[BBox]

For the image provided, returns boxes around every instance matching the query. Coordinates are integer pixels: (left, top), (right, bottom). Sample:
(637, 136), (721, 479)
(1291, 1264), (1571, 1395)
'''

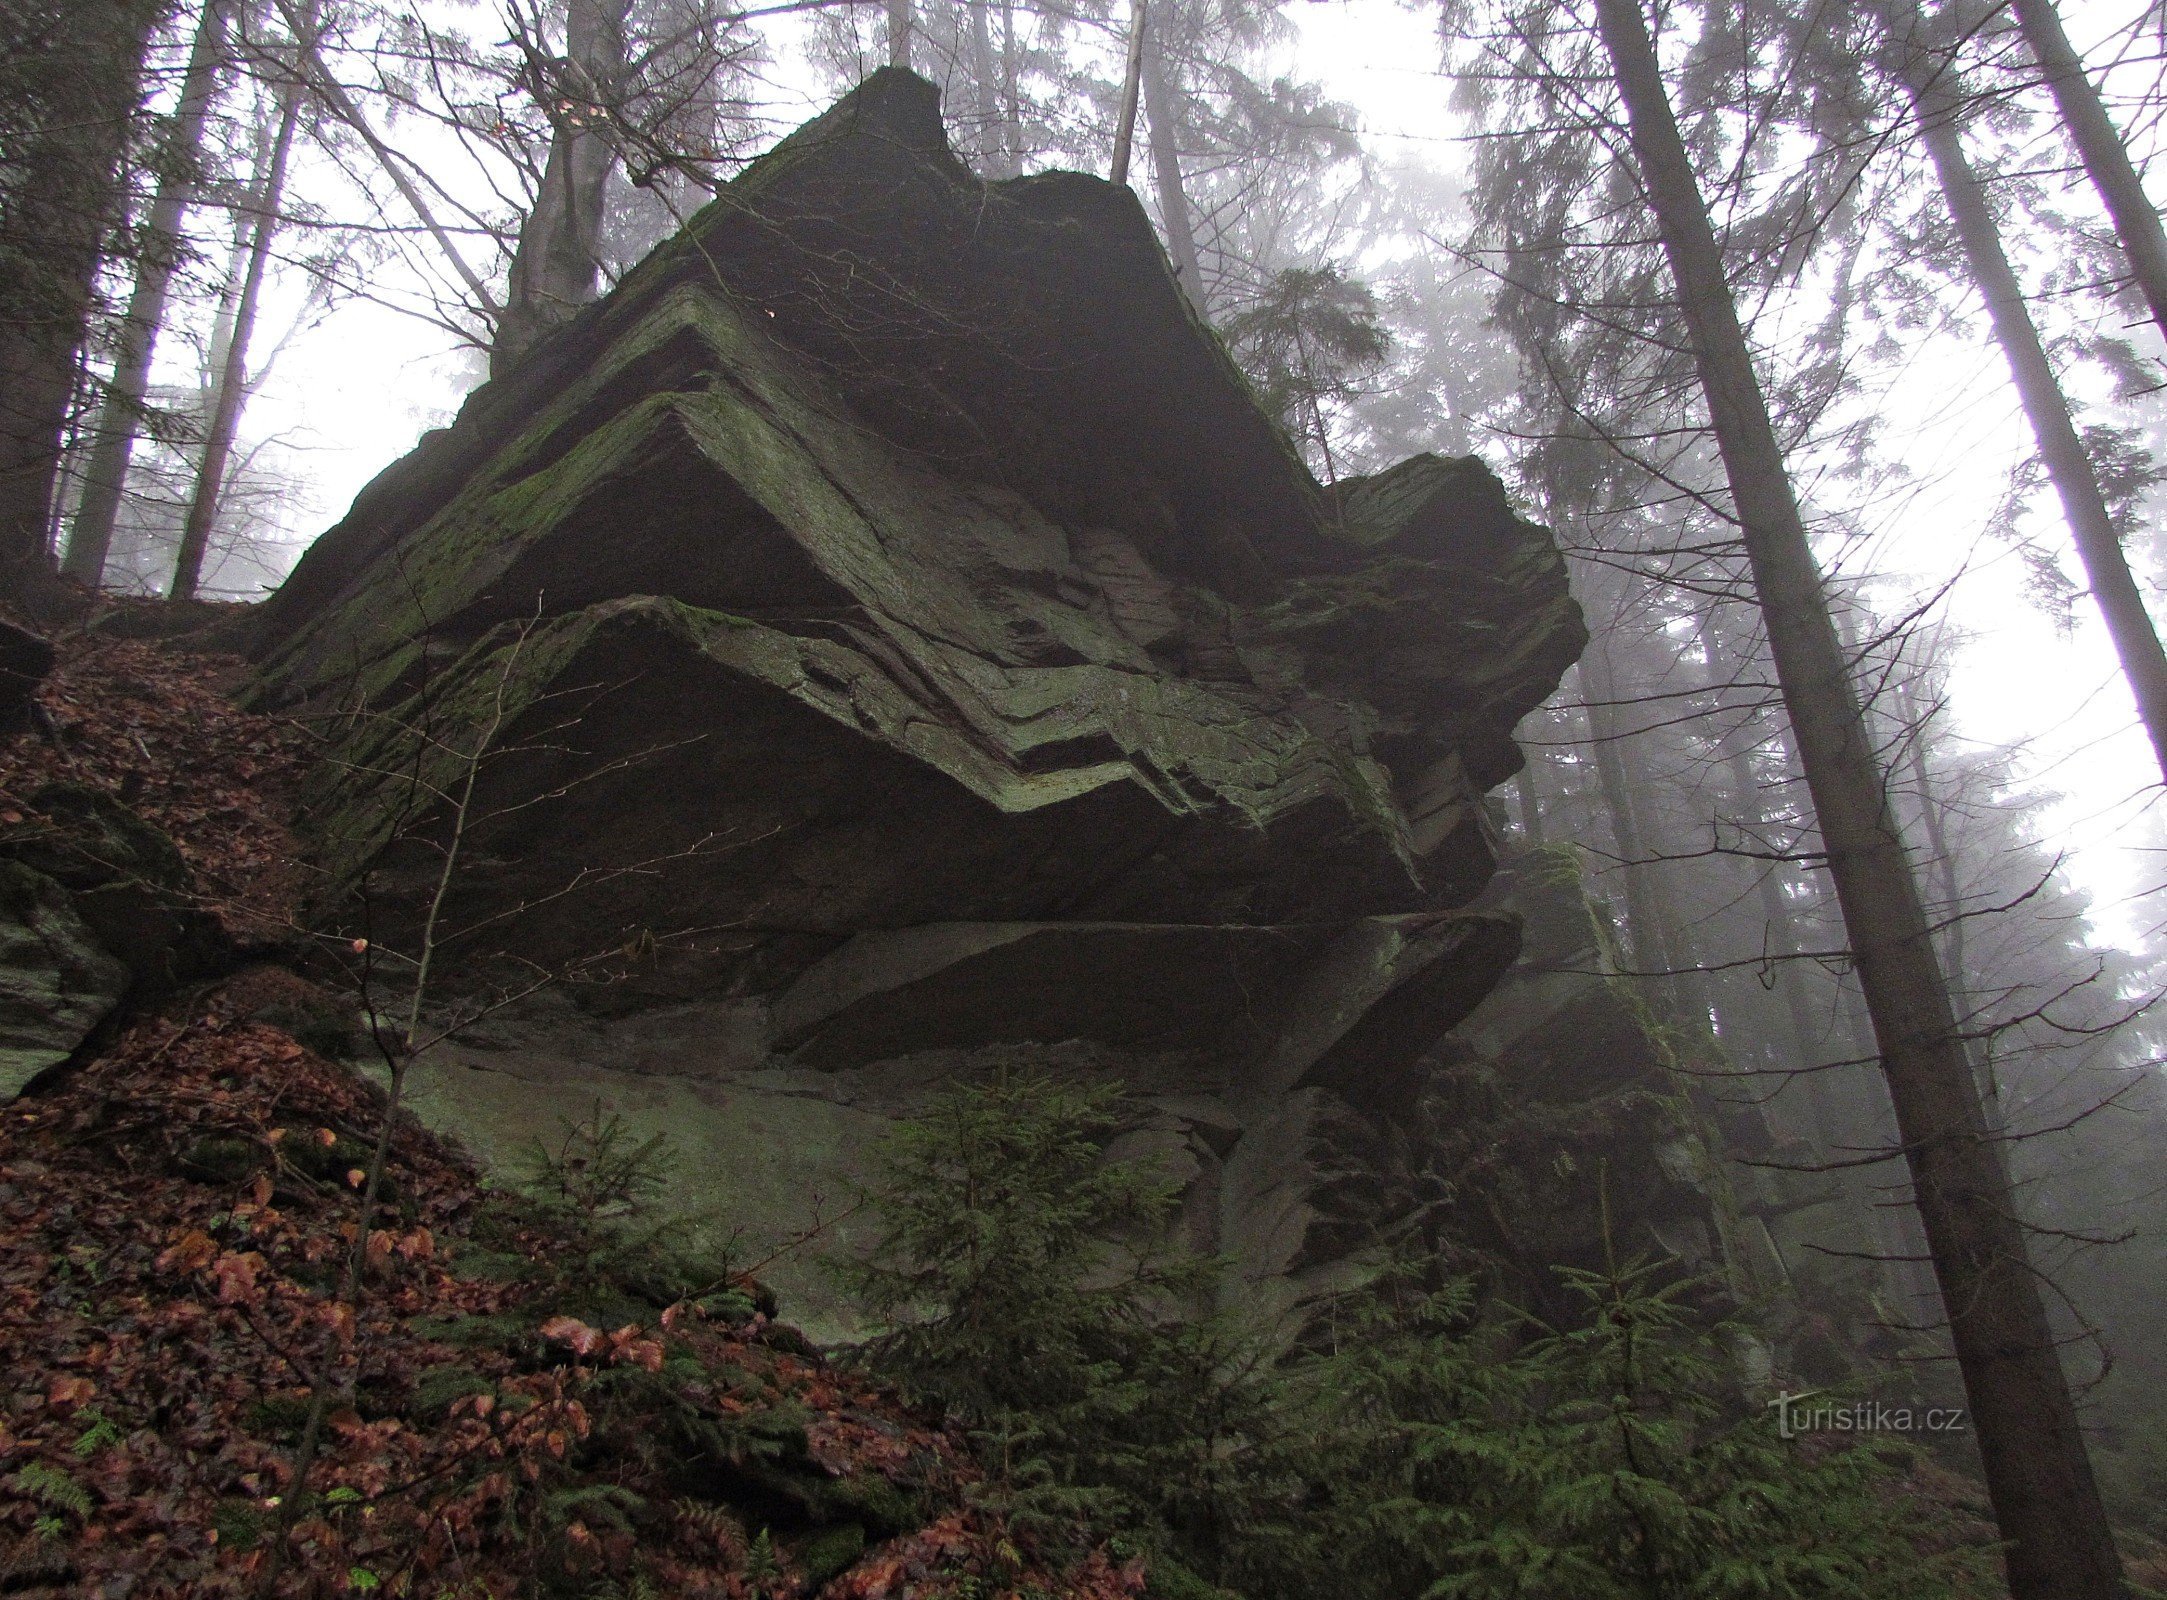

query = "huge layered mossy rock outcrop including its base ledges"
(254, 72), (1584, 1296)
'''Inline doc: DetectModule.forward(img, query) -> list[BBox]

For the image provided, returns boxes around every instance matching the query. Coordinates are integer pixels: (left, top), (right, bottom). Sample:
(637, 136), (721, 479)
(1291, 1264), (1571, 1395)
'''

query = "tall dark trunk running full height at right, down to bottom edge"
(1595, 0), (2126, 1600)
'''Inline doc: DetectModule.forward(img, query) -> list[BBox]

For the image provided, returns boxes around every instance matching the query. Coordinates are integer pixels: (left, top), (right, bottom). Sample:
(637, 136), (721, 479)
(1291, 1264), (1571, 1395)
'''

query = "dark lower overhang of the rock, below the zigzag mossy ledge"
(310, 598), (1456, 997)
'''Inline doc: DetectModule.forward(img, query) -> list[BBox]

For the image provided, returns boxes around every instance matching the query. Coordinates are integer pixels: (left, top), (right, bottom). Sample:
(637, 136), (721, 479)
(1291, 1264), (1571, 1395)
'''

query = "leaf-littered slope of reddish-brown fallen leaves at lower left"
(0, 602), (1144, 1600)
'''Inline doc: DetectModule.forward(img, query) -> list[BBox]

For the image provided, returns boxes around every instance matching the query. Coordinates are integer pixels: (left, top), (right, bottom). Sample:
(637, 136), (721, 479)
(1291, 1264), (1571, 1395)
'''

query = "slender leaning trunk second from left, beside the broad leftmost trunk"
(61, 0), (230, 588)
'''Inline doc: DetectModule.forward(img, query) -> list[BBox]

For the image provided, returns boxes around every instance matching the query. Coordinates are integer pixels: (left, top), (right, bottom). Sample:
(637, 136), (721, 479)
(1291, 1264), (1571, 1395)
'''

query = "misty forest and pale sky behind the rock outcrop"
(12, 0), (2167, 1569)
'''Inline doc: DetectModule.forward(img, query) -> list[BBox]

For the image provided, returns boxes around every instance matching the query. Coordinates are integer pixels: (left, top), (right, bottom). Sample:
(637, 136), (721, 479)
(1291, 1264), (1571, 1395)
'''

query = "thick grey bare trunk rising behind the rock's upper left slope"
(490, 0), (631, 377)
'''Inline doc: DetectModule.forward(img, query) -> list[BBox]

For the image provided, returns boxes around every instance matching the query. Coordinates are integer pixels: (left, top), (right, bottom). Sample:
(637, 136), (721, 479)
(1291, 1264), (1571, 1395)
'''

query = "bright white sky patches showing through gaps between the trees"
(219, 0), (2167, 943)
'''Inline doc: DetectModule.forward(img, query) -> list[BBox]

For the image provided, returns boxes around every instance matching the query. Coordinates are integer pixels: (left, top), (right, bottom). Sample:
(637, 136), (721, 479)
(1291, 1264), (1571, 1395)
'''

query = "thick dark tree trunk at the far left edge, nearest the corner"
(0, 0), (163, 577)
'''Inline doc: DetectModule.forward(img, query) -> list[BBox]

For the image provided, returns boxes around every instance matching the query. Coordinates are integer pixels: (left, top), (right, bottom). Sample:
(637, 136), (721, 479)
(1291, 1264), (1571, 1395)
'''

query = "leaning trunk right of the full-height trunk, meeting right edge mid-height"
(1896, 37), (2167, 776)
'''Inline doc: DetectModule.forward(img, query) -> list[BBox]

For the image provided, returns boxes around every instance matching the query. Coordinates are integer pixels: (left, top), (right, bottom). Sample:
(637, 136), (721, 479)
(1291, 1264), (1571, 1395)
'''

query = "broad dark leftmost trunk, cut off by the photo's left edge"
(0, 0), (160, 581)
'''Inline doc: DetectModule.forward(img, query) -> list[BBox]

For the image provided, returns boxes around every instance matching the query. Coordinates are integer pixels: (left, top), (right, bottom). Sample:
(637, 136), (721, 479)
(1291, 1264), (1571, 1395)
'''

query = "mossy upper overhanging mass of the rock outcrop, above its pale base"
(256, 74), (1582, 986)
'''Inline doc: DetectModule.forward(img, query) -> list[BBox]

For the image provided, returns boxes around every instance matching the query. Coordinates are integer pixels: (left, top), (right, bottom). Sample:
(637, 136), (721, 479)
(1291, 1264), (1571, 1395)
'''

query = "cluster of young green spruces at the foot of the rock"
(836, 1057), (1987, 1600)
